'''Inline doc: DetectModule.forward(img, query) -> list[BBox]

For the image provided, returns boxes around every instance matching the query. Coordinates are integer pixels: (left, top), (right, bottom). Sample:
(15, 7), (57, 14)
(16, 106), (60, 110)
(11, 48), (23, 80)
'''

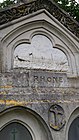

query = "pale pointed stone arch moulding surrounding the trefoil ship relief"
(2, 11), (78, 75)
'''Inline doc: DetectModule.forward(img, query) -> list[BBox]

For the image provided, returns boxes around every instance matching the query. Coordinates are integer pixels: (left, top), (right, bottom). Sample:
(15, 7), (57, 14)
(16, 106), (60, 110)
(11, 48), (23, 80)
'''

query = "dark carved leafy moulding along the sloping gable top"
(0, 0), (79, 37)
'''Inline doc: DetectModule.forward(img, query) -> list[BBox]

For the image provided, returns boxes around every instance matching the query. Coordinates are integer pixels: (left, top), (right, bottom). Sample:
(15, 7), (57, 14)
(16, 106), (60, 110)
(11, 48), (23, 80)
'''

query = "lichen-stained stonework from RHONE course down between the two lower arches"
(0, 69), (79, 140)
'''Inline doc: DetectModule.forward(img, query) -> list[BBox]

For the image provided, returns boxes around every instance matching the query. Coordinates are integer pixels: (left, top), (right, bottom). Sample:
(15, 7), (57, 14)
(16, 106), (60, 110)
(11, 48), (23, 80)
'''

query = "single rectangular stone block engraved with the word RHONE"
(30, 70), (67, 87)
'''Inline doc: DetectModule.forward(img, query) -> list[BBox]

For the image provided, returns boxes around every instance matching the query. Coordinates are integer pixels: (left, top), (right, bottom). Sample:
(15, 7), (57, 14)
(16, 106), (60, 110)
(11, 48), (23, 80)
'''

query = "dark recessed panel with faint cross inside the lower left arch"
(0, 120), (33, 140)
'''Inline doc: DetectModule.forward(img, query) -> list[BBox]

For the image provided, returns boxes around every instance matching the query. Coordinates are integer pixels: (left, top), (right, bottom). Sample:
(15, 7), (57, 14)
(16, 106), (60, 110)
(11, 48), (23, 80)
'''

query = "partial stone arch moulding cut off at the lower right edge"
(65, 107), (79, 140)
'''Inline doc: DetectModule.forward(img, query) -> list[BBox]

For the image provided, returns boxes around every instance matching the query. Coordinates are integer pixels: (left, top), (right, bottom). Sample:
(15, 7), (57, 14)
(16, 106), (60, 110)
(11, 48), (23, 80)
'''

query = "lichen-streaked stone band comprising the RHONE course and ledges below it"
(0, 69), (79, 110)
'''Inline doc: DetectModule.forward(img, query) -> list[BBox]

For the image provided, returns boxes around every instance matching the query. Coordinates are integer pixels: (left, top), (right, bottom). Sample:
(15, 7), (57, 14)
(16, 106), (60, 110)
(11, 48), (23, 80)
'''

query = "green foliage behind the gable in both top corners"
(0, 0), (79, 22)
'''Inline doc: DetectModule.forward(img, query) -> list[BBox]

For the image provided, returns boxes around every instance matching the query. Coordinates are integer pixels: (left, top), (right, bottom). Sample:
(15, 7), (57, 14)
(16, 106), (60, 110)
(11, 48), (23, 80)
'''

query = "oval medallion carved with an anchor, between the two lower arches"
(49, 104), (65, 131)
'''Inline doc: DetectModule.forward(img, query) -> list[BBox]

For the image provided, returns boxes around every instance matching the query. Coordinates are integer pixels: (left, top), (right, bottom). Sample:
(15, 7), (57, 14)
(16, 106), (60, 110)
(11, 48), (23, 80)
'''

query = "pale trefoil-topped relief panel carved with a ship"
(14, 35), (69, 71)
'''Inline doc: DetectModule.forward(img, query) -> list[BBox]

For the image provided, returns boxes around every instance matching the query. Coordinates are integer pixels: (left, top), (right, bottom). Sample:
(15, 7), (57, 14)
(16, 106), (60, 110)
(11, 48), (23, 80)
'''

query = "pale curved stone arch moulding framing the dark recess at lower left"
(0, 106), (52, 140)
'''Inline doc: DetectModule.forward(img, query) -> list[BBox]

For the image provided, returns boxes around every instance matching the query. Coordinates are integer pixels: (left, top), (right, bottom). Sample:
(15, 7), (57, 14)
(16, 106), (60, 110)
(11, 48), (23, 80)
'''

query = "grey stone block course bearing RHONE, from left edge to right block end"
(0, 69), (68, 88)
